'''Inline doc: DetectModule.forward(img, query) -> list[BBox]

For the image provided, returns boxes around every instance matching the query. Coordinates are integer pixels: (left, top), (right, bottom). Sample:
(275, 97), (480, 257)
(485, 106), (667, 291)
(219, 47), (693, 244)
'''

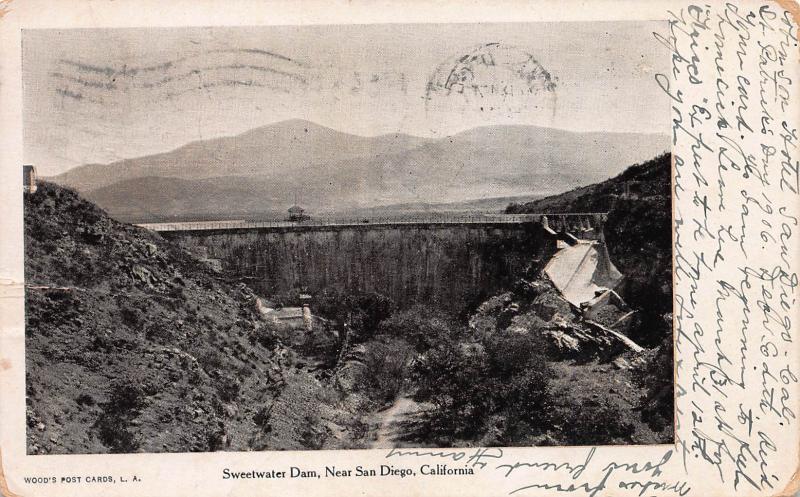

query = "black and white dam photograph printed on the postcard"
(20, 20), (676, 454)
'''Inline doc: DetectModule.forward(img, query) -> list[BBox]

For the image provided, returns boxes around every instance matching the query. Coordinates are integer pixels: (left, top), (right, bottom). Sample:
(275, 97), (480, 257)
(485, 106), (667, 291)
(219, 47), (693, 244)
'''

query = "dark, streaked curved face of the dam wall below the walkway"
(162, 222), (556, 311)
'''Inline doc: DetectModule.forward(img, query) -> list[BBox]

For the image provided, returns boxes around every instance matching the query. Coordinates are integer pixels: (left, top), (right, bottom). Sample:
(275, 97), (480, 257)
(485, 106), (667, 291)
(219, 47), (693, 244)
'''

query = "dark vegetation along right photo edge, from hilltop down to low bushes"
(506, 154), (673, 434)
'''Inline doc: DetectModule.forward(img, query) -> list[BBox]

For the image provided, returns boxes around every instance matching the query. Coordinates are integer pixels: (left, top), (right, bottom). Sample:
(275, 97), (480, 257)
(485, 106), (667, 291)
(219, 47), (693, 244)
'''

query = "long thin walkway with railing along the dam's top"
(137, 212), (606, 231)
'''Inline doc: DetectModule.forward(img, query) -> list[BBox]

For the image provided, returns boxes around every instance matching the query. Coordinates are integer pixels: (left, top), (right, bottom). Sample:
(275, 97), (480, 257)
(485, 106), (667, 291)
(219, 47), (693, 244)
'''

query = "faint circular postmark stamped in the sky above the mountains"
(425, 43), (557, 123)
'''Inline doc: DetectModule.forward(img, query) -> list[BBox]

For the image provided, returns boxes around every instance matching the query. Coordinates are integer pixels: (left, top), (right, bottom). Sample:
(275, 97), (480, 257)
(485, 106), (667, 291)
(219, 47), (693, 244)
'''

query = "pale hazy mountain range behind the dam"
(53, 120), (669, 221)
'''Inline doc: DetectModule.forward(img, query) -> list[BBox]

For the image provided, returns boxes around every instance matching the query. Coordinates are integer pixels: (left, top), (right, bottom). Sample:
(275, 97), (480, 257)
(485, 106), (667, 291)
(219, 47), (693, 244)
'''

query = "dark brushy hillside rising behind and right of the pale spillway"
(506, 154), (672, 313)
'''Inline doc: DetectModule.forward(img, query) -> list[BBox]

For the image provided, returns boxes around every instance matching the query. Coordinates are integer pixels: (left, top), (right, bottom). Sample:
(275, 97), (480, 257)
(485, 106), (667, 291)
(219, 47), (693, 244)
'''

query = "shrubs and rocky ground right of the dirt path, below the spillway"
(320, 279), (672, 447)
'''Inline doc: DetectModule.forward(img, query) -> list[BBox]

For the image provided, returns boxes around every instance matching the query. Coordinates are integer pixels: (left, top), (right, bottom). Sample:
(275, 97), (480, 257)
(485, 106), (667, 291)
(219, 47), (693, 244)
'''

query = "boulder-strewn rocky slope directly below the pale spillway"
(469, 278), (673, 446)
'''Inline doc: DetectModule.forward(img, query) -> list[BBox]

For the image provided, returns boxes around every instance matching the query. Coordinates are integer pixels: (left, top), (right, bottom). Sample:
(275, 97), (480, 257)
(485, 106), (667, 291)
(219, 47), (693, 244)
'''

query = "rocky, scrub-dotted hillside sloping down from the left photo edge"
(25, 183), (338, 454)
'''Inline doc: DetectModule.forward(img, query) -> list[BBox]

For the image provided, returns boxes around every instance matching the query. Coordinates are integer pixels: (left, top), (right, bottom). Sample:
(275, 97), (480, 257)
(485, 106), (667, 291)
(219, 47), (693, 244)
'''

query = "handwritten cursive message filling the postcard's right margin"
(655, 2), (800, 491)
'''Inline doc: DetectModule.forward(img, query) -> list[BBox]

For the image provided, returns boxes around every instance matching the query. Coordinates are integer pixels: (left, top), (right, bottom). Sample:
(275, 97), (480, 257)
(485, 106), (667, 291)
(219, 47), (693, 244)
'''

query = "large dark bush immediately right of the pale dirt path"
(415, 334), (553, 443)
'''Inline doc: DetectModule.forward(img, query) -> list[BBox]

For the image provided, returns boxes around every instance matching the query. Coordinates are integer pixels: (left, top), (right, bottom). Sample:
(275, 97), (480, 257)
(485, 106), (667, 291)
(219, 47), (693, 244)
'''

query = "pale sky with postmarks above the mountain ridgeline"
(22, 21), (669, 176)
